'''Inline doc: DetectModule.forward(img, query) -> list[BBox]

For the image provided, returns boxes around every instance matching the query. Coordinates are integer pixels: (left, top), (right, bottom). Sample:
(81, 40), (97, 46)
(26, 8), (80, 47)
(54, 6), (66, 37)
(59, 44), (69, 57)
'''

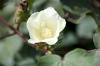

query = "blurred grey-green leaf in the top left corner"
(0, 0), (18, 20)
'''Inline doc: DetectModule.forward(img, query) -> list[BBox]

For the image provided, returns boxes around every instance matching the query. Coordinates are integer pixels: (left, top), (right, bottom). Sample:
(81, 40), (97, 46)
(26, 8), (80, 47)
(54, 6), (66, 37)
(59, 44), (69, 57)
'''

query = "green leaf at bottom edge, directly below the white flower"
(38, 54), (62, 66)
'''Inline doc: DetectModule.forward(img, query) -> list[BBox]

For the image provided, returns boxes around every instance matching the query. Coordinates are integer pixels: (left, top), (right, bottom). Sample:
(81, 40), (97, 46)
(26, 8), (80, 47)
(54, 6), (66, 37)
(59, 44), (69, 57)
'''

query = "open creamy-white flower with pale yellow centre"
(27, 7), (66, 45)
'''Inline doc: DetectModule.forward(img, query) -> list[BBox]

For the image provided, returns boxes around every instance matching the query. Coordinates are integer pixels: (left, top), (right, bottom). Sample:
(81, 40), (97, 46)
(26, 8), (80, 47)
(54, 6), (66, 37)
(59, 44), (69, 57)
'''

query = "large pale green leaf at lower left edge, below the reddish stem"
(0, 35), (22, 66)
